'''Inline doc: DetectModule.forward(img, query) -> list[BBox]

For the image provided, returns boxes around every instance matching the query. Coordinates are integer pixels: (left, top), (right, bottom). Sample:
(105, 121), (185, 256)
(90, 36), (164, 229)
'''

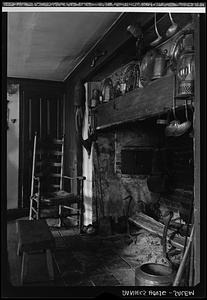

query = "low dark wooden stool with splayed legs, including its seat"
(17, 220), (55, 284)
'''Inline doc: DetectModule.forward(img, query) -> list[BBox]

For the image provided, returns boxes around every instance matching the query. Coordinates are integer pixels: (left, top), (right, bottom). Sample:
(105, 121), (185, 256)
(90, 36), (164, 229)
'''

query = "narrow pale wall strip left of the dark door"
(7, 85), (19, 209)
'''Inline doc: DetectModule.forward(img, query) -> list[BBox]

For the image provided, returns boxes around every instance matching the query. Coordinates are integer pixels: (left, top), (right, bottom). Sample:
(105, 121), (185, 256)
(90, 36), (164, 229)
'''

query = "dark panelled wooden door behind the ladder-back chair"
(19, 88), (65, 208)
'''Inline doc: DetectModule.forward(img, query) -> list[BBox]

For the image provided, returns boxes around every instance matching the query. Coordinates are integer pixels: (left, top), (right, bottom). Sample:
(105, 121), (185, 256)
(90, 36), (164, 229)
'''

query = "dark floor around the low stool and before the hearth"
(7, 221), (139, 287)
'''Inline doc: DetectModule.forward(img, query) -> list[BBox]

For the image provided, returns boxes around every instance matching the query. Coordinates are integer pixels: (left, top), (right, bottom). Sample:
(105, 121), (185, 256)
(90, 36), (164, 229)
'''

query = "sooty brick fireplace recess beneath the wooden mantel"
(92, 119), (193, 234)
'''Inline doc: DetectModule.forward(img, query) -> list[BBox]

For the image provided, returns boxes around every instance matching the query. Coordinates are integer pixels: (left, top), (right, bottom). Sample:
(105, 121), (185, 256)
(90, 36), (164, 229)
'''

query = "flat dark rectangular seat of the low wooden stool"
(17, 220), (55, 252)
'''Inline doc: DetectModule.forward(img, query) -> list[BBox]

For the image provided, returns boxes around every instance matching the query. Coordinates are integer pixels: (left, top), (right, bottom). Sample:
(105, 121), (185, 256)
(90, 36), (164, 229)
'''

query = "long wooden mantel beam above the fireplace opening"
(96, 75), (178, 130)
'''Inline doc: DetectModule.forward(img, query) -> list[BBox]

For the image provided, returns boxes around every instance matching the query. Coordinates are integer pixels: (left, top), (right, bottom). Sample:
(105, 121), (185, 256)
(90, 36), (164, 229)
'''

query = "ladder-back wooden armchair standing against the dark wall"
(29, 134), (86, 230)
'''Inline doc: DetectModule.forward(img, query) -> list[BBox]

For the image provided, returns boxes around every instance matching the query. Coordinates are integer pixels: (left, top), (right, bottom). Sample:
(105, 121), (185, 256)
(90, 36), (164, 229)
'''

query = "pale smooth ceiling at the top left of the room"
(7, 12), (120, 81)
